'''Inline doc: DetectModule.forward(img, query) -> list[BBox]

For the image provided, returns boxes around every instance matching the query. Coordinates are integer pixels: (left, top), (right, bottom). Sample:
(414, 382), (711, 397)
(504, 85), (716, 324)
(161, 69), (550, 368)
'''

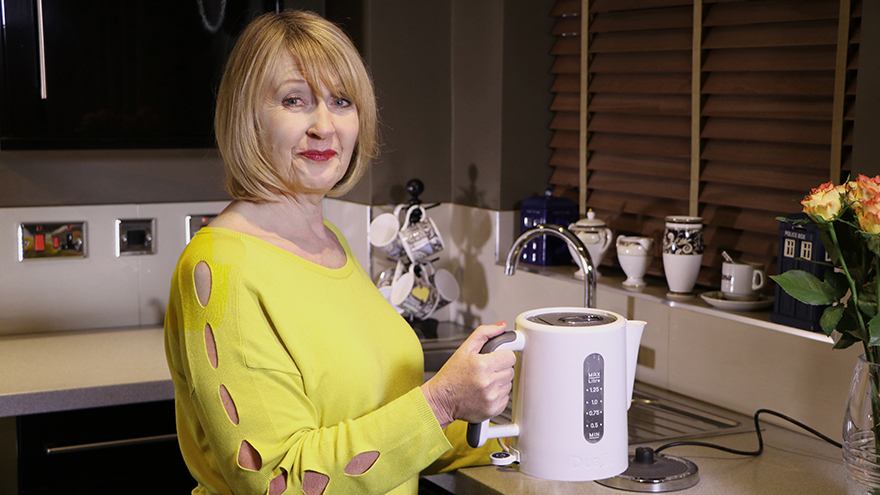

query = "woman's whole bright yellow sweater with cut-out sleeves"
(165, 222), (498, 495)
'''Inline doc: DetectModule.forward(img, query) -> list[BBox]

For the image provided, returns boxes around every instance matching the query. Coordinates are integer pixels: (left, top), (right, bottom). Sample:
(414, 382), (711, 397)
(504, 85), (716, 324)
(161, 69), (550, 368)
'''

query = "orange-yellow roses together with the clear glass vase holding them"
(771, 175), (880, 484)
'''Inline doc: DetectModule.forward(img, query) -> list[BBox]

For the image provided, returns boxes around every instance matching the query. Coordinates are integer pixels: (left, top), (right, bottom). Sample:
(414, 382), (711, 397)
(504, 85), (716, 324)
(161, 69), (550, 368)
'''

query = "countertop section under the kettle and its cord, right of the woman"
(435, 408), (846, 495)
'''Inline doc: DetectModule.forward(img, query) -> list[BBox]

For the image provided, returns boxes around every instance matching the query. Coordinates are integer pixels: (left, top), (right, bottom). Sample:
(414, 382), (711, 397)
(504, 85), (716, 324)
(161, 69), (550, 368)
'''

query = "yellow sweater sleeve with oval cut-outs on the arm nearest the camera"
(166, 238), (451, 495)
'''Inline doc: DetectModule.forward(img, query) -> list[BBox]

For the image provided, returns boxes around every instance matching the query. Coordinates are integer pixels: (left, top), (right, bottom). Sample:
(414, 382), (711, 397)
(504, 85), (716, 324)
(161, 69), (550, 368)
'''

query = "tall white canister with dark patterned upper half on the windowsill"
(663, 216), (703, 294)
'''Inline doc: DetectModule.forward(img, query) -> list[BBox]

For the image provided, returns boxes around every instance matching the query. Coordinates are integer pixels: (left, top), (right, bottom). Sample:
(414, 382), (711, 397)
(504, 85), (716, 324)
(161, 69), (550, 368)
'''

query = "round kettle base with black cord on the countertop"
(596, 447), (700, 493)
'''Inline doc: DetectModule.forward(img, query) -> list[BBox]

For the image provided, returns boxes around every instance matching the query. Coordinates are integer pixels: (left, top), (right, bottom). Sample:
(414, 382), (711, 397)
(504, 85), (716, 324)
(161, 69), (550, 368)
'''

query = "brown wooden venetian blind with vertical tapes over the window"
(551, 0), (860, 285)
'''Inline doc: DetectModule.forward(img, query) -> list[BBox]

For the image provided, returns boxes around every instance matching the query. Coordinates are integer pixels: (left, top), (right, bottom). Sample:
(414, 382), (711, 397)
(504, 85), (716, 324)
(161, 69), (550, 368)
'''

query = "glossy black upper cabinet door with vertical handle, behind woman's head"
(0, 0), (276, 150)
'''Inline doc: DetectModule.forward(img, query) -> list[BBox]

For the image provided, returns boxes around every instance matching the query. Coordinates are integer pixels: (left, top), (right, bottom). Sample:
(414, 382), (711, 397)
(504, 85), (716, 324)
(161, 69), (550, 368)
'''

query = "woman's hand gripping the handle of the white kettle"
(421, 322), (516, 428)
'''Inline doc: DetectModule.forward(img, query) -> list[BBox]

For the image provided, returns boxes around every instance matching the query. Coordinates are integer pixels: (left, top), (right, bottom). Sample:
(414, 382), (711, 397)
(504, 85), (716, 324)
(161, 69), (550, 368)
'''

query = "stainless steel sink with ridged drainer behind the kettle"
(422, 338), (754, 446)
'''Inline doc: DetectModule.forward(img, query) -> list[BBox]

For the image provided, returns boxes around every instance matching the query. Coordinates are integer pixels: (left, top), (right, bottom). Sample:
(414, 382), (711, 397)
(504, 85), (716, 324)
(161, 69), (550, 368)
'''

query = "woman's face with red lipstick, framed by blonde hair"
(259, 54), (358, 195)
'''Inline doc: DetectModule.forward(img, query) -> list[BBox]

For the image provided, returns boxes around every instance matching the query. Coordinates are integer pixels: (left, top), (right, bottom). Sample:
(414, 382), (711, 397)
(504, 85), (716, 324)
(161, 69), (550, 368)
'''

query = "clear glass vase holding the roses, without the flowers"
(843, 354), (880, 495)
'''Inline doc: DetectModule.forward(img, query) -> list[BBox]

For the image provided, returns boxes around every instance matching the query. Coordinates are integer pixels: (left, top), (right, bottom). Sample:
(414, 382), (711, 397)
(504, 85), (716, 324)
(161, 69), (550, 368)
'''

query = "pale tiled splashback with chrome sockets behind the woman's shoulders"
(0, 200), (369, 334)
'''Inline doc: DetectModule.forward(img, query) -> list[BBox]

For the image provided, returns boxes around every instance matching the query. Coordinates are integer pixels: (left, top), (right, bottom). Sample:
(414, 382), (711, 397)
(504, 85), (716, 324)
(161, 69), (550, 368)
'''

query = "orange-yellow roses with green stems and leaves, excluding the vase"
(770, 175), (880, 364)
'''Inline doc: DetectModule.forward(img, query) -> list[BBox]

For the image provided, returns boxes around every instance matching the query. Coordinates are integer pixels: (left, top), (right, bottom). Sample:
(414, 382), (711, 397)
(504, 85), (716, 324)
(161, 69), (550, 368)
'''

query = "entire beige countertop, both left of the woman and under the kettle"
(0, 327), (846, 495)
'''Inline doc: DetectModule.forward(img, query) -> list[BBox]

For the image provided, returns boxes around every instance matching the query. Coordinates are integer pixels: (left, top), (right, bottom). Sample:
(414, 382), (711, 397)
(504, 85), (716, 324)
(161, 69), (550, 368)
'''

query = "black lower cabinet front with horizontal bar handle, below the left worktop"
(13, 400), (196, 495)
